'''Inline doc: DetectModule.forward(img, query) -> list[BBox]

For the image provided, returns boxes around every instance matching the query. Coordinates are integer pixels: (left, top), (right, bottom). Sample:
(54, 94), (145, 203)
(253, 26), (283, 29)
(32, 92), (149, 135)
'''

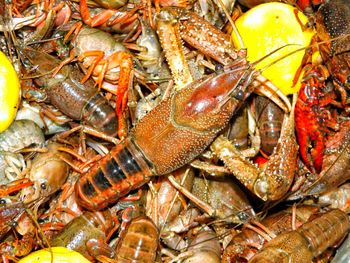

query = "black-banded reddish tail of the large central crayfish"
(75, 137), (155, 210)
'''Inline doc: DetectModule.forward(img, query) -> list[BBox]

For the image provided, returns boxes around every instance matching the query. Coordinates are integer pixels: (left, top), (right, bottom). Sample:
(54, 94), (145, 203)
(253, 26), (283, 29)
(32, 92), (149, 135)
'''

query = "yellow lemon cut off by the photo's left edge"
(0, 51), (21, 132)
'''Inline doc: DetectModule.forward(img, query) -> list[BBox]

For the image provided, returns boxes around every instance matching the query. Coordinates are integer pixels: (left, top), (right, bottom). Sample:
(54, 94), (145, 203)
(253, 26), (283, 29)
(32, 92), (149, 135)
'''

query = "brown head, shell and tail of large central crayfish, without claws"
(75, 58), (259, 210)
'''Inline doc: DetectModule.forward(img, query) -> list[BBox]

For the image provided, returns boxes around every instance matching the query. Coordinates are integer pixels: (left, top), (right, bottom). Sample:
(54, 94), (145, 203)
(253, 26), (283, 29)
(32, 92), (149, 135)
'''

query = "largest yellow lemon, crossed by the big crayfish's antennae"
(232, 2), (315, 95)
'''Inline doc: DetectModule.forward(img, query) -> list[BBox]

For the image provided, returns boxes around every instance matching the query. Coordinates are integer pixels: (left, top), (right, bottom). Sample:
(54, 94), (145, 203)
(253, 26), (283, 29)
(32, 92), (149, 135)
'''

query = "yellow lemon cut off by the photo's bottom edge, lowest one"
(18, 247), (90, 263)
